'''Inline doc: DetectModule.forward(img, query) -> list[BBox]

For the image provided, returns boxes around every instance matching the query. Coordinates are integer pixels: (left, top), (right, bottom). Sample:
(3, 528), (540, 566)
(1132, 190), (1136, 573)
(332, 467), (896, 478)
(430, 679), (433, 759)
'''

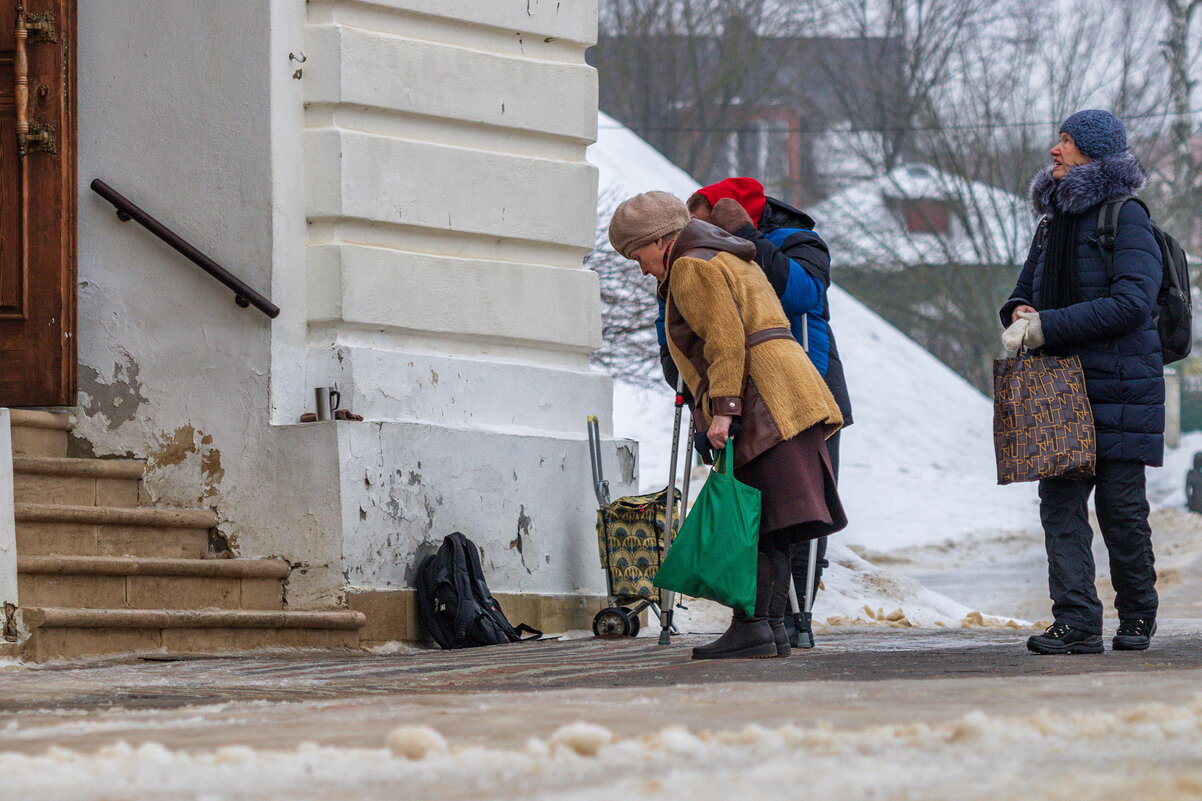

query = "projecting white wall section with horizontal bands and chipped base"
(300, 0), (633, 594)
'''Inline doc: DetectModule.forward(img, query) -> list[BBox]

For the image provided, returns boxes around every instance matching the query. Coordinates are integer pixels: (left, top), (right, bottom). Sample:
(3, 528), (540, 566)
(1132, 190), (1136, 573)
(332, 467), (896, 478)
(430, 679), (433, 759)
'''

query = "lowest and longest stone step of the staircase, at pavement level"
(23, 606), (367, 661)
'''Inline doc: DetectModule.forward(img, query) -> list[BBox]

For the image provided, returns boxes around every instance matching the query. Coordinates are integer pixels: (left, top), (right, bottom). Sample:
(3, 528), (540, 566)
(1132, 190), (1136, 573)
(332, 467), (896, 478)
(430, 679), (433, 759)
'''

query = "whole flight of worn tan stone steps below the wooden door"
(7, 409), (367, 661)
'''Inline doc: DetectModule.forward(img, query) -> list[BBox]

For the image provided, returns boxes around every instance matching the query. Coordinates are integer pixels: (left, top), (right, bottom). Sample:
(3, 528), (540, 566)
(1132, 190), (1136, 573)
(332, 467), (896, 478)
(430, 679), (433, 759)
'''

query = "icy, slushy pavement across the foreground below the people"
(0, 629), (1202, 801)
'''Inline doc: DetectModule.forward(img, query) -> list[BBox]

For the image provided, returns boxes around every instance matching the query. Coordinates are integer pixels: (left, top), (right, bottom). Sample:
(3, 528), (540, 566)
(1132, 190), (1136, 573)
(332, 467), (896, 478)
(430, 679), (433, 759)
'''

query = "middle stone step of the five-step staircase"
(13, 504), (218, 559)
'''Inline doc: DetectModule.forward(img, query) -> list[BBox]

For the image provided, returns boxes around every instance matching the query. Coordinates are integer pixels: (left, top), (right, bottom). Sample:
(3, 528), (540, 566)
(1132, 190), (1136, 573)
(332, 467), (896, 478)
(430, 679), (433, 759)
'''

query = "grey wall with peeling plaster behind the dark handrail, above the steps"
(75, 0), (344, 606)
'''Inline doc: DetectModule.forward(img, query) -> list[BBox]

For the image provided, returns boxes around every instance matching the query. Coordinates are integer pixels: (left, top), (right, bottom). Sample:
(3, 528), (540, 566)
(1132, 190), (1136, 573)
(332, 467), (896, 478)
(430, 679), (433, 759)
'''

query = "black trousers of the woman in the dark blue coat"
(1040, 461), (1158, 634)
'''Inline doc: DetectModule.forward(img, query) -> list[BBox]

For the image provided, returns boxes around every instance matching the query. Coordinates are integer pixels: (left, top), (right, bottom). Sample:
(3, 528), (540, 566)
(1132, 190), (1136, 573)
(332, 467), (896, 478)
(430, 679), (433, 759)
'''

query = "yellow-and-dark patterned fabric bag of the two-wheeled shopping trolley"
(597, 490), (680, 604)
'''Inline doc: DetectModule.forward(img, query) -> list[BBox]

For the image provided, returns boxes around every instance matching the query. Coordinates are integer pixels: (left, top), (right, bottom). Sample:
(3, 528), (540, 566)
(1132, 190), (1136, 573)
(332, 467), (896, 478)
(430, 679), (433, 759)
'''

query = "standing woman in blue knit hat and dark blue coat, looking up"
(1001, 108), (1165, 654)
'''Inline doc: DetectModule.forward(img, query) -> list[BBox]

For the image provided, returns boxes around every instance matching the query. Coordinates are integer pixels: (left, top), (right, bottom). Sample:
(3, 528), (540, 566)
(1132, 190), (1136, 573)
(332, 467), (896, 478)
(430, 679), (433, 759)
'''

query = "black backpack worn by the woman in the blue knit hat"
(1094, 195), (1194, 364)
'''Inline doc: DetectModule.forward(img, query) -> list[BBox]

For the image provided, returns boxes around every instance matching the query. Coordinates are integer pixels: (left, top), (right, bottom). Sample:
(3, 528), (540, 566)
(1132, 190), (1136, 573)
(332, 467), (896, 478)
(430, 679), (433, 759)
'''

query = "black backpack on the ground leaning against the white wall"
(417, 532), (542, 649)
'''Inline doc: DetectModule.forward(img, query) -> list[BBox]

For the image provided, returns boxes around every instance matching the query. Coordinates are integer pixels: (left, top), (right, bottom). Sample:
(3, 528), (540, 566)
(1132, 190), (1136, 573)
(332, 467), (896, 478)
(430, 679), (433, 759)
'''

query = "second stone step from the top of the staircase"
(12, 456), (145, 506)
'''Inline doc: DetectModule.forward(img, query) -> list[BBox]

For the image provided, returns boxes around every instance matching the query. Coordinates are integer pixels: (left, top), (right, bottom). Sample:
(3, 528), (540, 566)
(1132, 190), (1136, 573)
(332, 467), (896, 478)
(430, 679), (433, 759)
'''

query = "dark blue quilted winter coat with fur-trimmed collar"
(1001, 153), (1165, 467)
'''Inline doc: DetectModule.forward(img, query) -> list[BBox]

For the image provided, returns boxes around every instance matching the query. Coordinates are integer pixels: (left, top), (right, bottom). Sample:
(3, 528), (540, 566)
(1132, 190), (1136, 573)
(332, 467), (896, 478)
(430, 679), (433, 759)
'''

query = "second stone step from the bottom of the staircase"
(17, 556), (290, 610)
